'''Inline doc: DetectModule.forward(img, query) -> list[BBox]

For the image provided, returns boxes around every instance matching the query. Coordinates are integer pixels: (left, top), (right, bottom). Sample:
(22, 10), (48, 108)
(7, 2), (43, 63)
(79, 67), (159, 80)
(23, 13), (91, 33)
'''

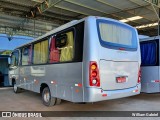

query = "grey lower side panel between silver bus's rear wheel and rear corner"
(44, 62), (83, 102)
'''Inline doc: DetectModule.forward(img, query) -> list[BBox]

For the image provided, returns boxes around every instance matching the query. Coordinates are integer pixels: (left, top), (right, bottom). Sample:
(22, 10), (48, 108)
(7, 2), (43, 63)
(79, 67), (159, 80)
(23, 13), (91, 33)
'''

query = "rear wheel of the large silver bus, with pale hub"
(42, 87), (56, 106)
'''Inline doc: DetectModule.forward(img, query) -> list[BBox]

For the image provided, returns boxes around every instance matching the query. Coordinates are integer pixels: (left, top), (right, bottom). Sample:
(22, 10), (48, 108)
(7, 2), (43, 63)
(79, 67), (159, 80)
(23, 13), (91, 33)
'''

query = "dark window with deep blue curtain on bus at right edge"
(140, 40), (159, 66)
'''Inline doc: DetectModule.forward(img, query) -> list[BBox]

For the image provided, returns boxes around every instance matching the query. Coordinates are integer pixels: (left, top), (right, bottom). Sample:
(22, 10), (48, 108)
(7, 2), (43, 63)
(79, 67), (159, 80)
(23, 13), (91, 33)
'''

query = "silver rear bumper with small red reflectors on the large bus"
(84, 84), (141, 102)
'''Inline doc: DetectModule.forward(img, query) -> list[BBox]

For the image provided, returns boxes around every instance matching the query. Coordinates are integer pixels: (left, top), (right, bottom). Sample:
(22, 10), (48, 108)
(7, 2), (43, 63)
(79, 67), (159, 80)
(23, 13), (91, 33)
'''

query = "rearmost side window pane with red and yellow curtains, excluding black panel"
(49, 31), (74, 63)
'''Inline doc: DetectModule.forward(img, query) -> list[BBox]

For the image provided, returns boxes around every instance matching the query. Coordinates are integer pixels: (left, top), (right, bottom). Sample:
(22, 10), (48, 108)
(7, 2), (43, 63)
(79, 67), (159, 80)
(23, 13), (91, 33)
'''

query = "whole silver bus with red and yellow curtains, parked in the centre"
(9, 16), (141, 106)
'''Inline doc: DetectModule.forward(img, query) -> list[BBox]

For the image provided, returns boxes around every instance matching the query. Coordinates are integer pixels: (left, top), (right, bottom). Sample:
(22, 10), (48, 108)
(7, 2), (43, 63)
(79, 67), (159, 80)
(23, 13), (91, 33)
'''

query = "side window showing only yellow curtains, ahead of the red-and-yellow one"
(33, 40), (48, 64)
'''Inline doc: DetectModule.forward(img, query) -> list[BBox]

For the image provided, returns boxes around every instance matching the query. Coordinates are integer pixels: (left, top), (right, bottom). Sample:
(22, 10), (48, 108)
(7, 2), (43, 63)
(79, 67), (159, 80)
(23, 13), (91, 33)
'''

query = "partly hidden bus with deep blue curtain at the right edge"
(140, 36), (160, 93)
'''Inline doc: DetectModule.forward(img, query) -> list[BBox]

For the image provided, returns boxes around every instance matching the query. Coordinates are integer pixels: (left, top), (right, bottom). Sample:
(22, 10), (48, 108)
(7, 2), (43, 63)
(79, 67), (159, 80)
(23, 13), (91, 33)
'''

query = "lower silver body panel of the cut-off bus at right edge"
(141, 66), (160, 93)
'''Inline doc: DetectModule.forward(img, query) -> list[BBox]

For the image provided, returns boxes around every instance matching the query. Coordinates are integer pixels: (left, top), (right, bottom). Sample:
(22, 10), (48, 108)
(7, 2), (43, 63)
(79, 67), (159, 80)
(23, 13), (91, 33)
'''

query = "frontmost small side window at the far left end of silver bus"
(11, 50), (19, 67)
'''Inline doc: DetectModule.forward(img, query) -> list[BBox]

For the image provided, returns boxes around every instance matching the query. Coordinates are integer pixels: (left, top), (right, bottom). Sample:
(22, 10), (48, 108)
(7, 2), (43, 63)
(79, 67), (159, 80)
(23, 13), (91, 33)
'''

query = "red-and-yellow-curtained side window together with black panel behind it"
(49, 22), (84, 63)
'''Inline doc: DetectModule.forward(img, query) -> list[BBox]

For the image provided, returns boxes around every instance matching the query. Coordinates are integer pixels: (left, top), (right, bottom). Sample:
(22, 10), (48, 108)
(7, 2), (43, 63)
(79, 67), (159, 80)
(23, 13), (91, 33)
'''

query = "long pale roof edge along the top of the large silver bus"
(15, 16), (135, 49)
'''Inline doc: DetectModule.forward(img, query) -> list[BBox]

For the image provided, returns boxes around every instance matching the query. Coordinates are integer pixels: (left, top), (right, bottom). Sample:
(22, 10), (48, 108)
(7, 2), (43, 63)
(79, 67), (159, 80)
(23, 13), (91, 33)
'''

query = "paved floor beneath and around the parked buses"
(0, 88), (160, 120)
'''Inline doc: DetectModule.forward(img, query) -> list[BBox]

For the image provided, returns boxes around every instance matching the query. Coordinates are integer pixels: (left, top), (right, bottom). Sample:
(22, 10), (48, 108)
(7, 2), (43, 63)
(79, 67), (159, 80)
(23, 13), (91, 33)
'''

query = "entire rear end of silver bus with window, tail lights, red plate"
(84, 17), (141, 102)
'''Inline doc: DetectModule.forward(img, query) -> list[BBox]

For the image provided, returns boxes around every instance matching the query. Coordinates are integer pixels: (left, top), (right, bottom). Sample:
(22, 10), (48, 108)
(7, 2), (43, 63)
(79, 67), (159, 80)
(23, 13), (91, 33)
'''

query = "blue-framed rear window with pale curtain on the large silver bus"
(97, 20), (137, 50)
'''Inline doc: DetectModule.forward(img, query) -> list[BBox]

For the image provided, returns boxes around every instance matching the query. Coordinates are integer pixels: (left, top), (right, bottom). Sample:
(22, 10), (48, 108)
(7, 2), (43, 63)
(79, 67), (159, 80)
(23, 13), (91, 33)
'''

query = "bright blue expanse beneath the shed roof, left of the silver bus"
(0, 34), (34, 50)
